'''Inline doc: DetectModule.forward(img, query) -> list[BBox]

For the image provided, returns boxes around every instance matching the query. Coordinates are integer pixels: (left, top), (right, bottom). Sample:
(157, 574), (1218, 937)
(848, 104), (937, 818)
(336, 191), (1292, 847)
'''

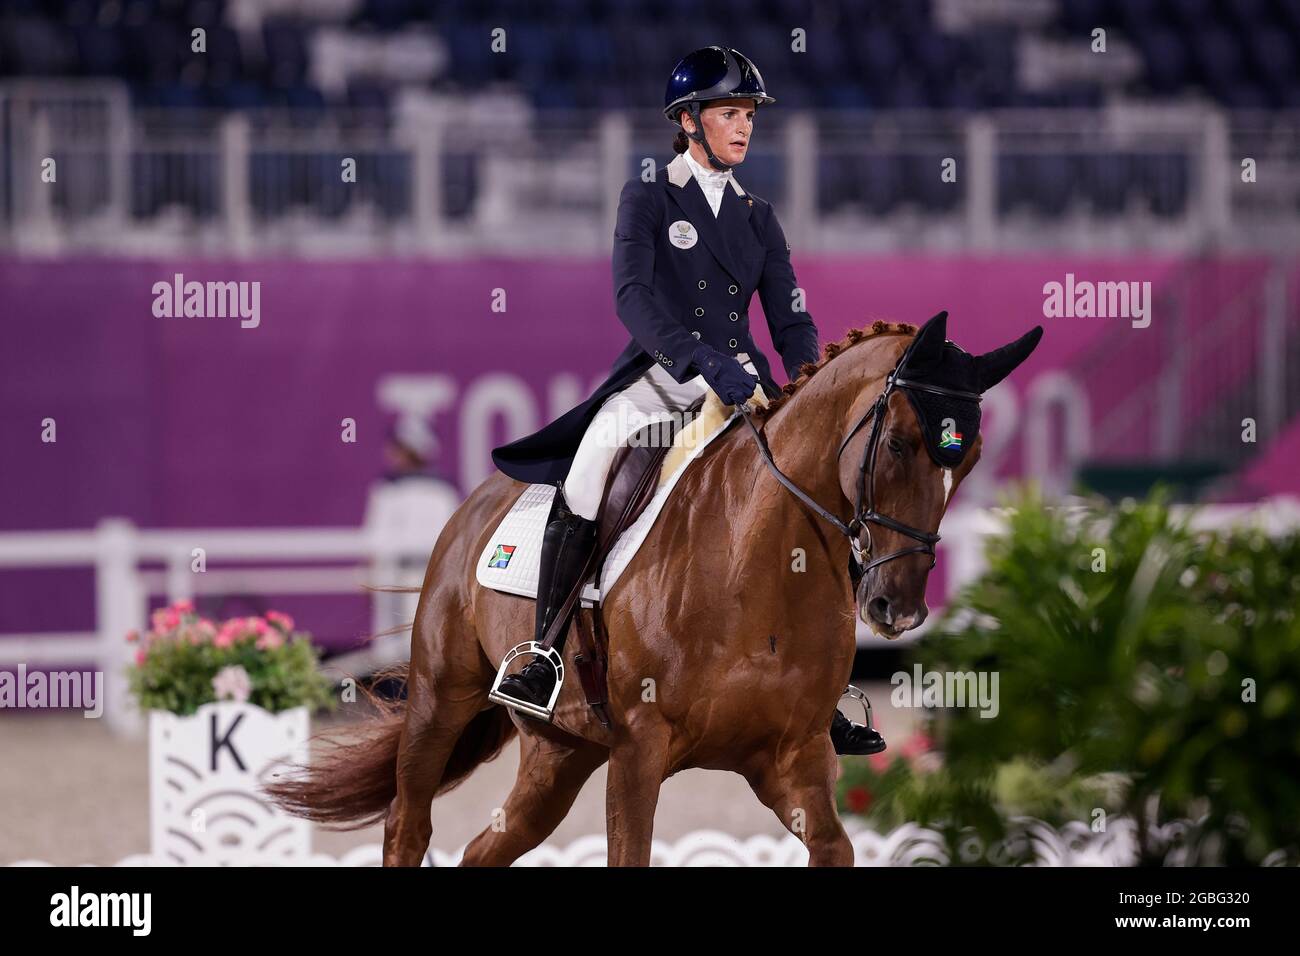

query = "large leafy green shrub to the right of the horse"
(841, 494), (1300, 864)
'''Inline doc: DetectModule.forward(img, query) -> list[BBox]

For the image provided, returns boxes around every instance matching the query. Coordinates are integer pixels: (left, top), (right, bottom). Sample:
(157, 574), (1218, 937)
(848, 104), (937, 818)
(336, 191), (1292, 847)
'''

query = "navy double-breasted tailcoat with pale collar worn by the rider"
(491, 155), (819, 484)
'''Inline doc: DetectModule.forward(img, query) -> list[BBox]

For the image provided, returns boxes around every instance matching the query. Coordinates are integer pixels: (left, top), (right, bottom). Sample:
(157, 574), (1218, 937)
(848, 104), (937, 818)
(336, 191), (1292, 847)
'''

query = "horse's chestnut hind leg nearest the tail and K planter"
(384, 590), (491, 866)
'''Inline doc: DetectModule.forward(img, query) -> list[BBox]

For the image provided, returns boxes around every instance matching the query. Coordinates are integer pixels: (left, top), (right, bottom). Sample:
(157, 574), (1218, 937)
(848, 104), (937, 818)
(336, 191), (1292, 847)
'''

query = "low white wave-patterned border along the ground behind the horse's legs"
(12, 817), (1283, 866)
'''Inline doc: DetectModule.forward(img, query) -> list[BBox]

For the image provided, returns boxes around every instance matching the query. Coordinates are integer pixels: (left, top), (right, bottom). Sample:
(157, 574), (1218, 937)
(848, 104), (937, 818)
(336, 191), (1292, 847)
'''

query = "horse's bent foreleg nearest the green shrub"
(745, 734), (853, 866)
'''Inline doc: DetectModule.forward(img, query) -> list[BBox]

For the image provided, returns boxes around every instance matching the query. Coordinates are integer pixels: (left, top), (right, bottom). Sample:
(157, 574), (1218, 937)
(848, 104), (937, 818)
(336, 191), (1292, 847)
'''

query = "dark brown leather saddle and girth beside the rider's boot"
(562, 398), (705, 727)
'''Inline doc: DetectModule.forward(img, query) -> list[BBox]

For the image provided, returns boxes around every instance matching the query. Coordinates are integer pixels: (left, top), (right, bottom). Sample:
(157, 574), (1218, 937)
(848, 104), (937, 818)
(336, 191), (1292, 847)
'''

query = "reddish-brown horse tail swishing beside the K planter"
(264, 663), (516, 830)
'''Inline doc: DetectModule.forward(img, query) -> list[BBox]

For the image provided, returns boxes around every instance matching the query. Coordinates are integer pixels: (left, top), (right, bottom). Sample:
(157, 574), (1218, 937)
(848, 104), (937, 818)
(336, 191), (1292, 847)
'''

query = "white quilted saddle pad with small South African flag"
(476, 406), (740, 606)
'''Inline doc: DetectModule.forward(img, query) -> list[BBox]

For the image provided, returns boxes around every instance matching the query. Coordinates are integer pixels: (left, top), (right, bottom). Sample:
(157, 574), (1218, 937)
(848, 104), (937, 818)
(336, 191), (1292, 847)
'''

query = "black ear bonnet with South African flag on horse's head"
(896, 312), (1043, 468)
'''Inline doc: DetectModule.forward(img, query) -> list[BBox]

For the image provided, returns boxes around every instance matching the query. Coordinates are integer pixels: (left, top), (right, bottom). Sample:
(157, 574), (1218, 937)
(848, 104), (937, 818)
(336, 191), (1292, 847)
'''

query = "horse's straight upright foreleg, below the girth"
(605, 727), (670, 866)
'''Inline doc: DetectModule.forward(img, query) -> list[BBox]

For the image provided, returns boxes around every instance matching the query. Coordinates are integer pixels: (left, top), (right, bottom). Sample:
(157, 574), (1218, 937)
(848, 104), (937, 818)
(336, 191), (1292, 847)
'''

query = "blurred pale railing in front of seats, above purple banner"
(0, 81), (1300, 256)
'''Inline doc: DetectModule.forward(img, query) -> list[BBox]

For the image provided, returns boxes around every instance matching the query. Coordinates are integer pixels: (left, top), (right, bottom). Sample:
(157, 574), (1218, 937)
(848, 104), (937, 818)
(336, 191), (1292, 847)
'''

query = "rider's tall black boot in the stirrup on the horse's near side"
(497, 489), (598, 715)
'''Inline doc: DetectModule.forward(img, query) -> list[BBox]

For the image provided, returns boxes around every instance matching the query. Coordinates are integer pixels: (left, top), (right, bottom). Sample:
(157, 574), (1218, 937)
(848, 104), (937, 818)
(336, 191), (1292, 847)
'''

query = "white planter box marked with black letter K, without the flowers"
(150, 701), (311, 866)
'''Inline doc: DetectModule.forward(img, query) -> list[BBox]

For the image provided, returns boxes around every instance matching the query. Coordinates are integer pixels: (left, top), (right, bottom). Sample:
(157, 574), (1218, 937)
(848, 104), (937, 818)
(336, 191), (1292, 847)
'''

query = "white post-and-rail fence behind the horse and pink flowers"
(0, 497), (1300, 736)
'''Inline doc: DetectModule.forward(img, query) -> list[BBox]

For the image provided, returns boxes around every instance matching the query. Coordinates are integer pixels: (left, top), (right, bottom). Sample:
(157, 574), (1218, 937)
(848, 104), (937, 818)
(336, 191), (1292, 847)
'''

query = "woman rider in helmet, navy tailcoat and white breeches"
(493, 47), (884, 753)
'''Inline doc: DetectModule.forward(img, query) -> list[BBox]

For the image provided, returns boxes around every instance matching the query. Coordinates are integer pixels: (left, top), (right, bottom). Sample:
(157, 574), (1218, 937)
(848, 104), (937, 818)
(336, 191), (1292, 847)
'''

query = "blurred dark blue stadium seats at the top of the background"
(0, 0), (1300, 216)
